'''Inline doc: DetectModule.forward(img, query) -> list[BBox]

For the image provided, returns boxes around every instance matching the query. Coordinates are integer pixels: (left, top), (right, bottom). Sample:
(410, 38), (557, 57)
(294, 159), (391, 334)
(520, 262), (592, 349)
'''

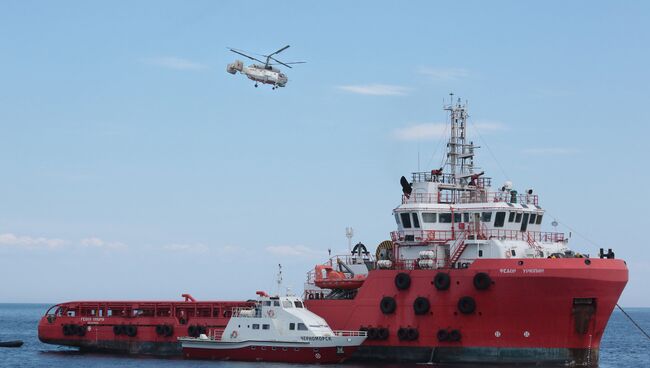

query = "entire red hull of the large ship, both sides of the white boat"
(39, 258), (628, 365)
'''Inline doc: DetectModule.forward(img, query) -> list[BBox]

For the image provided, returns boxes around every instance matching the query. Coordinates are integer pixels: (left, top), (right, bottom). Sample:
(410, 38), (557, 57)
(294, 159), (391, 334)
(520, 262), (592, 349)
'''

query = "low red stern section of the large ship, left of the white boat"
(38, 301), (253, 355)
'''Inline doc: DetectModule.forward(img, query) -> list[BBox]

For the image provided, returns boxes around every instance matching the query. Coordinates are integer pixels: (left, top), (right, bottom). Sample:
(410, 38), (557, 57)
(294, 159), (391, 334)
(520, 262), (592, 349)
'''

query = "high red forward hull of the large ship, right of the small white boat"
(305, 258), (628, 365)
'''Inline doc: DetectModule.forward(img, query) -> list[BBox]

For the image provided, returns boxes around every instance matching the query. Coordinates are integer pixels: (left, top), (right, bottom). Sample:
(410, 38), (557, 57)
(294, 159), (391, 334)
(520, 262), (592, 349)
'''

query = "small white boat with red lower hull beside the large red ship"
(179, 291), (367, 363)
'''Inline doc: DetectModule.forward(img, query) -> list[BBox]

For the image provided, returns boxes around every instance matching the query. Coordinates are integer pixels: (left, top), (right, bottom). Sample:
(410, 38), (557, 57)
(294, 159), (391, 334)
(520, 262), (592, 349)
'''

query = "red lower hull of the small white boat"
(183, 346), (356, 364)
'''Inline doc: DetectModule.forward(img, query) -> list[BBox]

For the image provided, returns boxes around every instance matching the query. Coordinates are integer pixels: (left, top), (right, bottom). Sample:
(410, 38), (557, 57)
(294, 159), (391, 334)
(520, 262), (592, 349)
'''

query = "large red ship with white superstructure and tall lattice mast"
(39, 100), (628, 366)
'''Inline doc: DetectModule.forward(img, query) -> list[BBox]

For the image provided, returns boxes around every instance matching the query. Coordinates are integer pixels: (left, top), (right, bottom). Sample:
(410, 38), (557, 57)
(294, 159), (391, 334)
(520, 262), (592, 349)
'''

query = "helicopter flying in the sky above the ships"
(226, 45), (305, 89)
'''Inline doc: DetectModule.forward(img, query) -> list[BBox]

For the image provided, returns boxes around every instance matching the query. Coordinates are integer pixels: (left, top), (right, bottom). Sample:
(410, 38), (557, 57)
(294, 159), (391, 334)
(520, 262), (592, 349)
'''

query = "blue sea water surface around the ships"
(0, 304), (650, 368)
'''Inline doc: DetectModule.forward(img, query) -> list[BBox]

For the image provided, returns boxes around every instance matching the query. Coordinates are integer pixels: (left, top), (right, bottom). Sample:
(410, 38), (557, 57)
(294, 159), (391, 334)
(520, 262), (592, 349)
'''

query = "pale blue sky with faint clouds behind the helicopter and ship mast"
(0, 1), (650, 306)
